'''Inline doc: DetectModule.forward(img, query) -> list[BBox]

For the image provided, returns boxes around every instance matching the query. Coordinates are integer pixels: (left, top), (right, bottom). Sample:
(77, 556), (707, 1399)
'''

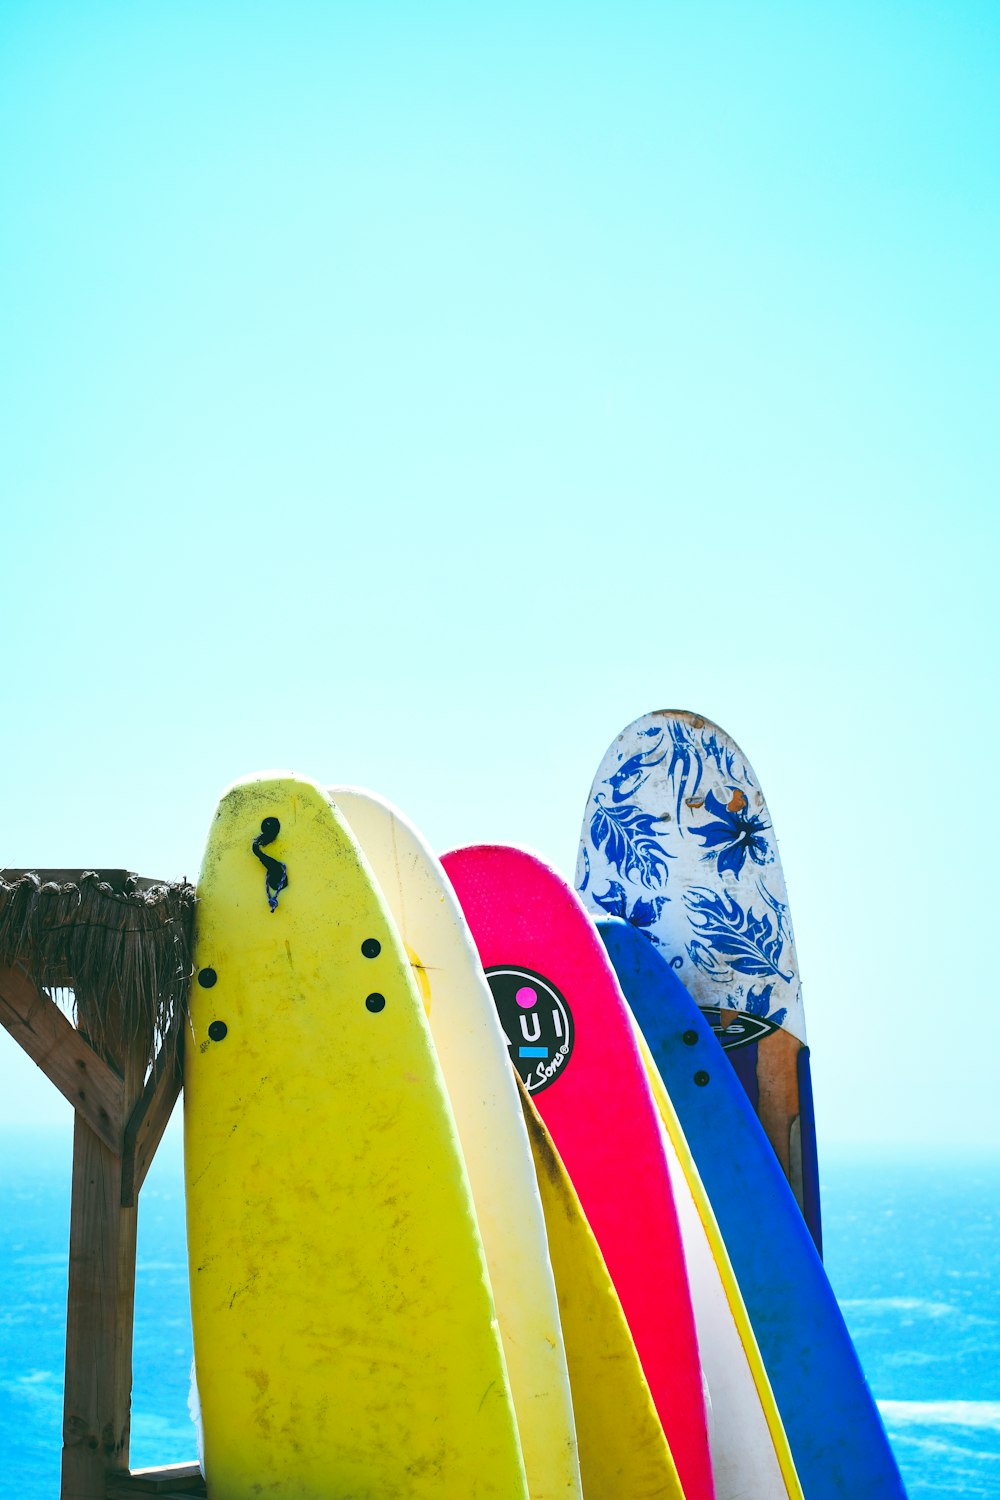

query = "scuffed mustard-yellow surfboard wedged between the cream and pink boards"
(511, 1070), (684, 1500)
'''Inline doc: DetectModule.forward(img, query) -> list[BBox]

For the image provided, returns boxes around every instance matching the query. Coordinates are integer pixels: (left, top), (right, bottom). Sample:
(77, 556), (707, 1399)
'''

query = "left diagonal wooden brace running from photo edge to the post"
(0, 966), (124, 1154)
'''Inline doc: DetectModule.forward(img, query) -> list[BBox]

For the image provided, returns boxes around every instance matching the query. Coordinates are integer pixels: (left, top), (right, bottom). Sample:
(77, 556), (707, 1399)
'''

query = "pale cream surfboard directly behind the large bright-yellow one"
(330, 786), (578, 1500)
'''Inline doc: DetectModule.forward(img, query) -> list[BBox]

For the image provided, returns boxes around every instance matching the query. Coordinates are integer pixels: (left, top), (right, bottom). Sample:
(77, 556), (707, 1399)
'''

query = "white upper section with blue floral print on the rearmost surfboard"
(577, 713), (805, 1041)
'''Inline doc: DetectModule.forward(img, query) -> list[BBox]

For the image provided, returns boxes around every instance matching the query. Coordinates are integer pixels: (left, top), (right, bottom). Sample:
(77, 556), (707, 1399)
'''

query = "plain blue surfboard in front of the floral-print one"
(600, 921), (904, 1500)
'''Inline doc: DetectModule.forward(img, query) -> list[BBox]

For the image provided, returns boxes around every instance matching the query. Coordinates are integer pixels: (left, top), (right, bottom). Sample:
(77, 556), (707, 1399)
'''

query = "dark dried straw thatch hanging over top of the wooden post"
(0, 870), (195, 1067)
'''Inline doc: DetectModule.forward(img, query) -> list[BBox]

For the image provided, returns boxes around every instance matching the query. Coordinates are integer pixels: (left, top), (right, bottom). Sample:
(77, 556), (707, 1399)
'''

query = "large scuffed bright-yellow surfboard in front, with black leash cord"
(184, 776), (528, 1500)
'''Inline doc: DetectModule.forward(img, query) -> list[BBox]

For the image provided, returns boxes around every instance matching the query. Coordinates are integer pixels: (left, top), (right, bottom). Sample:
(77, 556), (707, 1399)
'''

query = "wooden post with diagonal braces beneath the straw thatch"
(0, 918), (197, 1500)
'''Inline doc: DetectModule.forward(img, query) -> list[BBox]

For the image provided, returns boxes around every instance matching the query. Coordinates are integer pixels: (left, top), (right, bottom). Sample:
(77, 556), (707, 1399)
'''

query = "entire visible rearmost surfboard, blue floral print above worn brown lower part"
(576, 710), (822, 1254)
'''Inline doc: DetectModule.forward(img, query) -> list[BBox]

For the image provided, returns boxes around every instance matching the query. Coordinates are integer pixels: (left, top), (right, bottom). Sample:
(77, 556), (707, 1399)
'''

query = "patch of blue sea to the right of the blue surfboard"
(820, 1154), (1000, 1500)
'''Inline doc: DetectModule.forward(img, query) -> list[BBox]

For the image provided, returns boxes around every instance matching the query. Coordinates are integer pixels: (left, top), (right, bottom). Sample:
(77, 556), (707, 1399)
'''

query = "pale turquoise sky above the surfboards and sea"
(0, 0), (1000, 1163)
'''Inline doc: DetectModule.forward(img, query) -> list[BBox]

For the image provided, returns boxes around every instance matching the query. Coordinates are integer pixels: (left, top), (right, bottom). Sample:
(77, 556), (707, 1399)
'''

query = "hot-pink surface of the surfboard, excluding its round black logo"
(442, 845), (714, 1500)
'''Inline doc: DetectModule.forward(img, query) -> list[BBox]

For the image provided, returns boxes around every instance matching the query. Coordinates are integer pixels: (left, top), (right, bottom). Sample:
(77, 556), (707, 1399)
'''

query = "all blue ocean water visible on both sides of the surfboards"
(0, 1130), (1000, 1500)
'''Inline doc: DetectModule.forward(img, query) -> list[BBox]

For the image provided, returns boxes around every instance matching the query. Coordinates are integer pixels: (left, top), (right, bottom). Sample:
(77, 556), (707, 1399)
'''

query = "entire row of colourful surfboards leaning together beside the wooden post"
(184, 713), (903, 1500)
